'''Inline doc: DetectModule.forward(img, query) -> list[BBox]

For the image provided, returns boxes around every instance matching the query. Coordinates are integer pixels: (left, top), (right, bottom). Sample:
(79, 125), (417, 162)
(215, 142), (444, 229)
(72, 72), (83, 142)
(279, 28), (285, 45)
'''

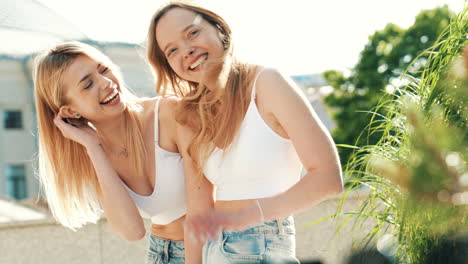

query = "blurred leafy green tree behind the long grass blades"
(323, 6), (454, 166)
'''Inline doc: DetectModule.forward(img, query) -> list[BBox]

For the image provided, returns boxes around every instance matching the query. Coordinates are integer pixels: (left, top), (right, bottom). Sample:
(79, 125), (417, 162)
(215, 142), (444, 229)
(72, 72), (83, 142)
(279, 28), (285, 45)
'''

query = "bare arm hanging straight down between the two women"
(177, 121), (219, 264)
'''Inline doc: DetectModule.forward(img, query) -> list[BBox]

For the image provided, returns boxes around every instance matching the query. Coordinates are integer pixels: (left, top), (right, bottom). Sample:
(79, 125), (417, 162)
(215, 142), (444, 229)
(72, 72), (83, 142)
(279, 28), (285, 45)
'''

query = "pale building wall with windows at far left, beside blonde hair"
(0, 56), (37, 199)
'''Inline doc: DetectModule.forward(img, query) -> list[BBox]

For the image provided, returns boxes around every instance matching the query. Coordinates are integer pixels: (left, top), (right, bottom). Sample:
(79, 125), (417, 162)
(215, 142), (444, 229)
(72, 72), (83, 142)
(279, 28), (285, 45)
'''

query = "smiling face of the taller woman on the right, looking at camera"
(156, 8), (225, 83)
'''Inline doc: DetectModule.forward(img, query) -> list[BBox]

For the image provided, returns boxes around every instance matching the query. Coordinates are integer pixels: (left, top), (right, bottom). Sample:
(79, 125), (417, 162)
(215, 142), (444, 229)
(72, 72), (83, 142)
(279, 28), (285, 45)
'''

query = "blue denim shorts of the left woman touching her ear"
(146, 235), (185, 264)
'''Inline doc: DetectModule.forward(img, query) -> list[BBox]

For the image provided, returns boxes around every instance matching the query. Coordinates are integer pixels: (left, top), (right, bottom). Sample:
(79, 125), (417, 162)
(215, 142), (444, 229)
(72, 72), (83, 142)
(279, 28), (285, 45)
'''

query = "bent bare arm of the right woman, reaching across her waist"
(219, 69), (343, 229)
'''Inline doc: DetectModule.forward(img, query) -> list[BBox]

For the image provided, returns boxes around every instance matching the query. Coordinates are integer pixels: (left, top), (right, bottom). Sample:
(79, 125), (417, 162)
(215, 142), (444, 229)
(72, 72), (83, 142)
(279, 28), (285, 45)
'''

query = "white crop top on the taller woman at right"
(204, 71), (302, 201)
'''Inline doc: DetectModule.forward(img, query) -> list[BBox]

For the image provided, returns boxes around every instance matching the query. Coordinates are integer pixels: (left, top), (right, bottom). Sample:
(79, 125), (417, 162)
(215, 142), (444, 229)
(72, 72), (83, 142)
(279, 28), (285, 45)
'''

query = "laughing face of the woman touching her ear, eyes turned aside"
(60, 55), (125, 122)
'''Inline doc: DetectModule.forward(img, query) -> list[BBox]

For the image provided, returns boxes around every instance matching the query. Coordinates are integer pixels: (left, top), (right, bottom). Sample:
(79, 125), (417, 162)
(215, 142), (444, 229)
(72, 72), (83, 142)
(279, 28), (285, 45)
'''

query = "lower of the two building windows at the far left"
(6, 164), (26, 200)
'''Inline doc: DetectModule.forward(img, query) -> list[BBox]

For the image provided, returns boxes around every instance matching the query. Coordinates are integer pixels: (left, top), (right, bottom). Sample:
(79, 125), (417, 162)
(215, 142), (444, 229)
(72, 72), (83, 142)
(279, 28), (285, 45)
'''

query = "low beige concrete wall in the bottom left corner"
(0, 220), (146, 264)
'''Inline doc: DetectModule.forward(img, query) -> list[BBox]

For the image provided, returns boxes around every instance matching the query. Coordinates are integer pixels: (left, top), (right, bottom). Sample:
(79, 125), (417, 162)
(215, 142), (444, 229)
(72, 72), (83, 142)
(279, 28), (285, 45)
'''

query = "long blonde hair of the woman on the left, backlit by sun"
(33, 42), (146, 230)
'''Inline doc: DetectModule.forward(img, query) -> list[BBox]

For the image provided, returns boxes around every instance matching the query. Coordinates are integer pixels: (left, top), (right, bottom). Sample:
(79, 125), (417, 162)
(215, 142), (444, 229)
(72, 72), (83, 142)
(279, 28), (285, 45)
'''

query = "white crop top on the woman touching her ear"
(124, 97), (187, 225)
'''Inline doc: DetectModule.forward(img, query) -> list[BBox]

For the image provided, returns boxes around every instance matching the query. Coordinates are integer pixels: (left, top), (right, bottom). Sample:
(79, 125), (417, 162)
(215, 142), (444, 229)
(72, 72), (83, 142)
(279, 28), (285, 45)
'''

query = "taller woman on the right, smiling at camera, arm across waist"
(148, 1), (343, 264)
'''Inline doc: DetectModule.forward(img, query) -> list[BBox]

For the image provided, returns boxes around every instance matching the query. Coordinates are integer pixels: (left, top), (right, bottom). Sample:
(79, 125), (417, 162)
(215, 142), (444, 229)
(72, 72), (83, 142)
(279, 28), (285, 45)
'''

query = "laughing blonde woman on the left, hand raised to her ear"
(34, 42), (186, 264)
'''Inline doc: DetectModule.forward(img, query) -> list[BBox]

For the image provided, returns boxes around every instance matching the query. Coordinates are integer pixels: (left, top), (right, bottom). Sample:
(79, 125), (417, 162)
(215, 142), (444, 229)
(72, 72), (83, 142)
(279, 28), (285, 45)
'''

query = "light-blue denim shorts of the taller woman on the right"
(203, 216), (299, 264)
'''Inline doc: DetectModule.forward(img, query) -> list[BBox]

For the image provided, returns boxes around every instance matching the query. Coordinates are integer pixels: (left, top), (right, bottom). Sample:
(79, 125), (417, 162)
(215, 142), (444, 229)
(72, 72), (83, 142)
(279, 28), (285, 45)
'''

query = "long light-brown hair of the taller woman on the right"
(147, 1), (256, 173)
